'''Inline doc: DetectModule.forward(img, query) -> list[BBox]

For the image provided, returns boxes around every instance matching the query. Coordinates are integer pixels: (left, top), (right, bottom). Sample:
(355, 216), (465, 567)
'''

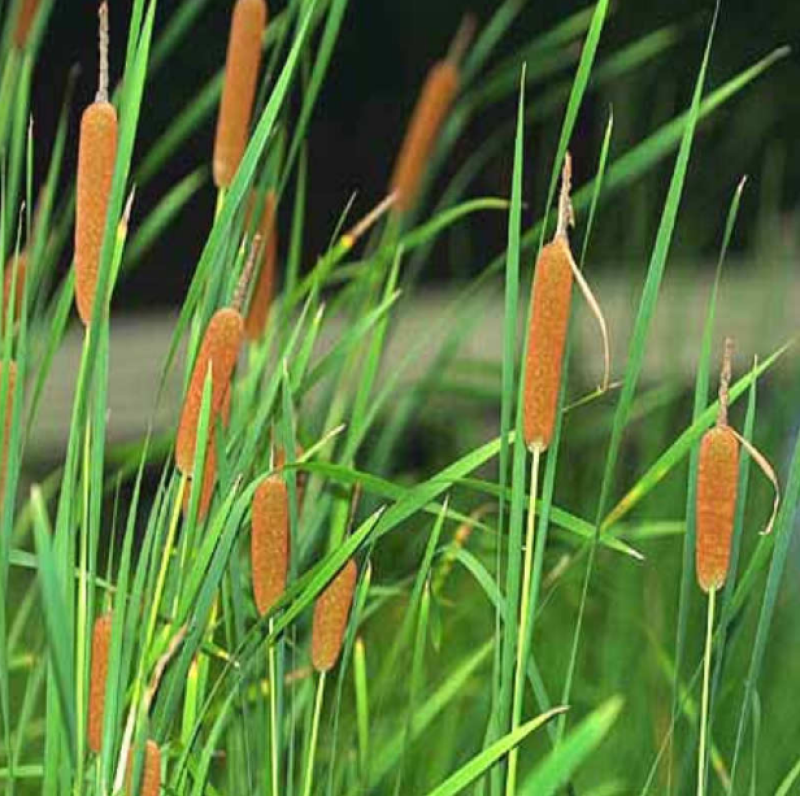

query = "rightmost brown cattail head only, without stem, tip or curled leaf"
(695, 425), (739, 592)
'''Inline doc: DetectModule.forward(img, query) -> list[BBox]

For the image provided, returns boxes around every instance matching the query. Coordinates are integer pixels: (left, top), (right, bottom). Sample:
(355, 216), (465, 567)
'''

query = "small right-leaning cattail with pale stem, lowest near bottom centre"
(303, 558), (358, 796)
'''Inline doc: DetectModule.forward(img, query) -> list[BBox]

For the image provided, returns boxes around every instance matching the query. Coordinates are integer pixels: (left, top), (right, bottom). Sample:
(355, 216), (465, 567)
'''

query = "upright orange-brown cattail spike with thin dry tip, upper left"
(75, 3), (117, 326)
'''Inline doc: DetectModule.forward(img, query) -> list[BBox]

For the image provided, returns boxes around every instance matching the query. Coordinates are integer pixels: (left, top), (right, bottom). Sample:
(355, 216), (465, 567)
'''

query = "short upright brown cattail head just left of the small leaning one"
(250, 475), (289, 616)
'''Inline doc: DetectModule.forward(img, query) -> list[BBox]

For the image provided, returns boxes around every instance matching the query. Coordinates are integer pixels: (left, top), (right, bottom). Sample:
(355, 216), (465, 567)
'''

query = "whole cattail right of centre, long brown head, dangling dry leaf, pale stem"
(506, 152), (610, 796)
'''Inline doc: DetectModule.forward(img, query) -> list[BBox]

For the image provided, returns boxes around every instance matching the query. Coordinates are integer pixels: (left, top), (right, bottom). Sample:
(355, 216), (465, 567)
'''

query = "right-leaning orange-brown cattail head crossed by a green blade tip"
(175, 307), (244, 476)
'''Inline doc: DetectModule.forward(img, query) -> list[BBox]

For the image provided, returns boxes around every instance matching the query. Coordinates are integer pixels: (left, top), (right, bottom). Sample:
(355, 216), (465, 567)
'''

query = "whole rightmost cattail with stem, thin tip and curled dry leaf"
(695, 338), (780, 796)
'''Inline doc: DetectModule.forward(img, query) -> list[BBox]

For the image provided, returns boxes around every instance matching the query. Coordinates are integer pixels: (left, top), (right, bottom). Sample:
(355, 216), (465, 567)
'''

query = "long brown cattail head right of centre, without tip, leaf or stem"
(523, 237), (573, 450)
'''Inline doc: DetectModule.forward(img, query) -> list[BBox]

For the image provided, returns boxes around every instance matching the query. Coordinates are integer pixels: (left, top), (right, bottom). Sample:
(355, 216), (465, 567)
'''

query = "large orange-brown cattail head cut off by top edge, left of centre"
(214, 0), (267, 188)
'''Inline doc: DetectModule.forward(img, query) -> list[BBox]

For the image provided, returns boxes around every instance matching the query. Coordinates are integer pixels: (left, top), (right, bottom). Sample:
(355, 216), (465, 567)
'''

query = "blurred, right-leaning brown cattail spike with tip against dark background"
(390, 17), (475, 212)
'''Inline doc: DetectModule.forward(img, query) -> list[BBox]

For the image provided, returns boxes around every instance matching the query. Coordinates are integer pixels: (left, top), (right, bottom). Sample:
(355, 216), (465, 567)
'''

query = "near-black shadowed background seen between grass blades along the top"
(25, 0), (800, 308)
